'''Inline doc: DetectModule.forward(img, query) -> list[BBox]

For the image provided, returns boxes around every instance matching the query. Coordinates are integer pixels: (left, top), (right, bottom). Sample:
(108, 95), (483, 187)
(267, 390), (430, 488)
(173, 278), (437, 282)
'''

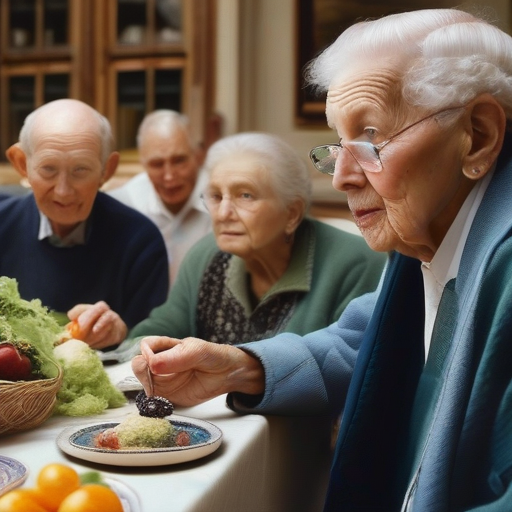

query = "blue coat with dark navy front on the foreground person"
(228, 134), (512, 512)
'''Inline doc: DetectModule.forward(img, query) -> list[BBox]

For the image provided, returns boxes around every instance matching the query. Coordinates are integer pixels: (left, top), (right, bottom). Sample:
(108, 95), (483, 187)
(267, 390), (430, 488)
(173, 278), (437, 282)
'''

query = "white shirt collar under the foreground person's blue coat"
(421, 168), (494, 359)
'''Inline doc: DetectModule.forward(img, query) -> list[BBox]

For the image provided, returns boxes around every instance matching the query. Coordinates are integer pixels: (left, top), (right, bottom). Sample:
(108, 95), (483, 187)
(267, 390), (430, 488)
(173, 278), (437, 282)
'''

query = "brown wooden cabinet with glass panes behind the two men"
(0, 0), (215, 157)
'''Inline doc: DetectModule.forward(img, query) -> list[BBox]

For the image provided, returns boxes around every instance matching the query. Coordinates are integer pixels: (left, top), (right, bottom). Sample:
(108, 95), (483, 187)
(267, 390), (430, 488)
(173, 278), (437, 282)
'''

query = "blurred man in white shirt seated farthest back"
(109, 110), (211, 283)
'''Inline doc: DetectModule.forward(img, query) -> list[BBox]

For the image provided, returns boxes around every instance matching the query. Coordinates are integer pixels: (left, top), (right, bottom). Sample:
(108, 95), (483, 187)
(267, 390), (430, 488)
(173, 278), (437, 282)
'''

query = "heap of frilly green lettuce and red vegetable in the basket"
(0, 276), (126, 416)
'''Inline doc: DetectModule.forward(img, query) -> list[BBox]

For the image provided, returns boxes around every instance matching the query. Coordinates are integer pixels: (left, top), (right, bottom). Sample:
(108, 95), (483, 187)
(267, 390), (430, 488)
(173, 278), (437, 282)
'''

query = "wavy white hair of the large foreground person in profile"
(306, 9), (512, 119)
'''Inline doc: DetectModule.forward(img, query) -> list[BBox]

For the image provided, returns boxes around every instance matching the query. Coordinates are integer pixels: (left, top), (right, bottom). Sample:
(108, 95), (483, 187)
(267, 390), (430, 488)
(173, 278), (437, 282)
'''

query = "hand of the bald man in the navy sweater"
(68, 301), (128, 349)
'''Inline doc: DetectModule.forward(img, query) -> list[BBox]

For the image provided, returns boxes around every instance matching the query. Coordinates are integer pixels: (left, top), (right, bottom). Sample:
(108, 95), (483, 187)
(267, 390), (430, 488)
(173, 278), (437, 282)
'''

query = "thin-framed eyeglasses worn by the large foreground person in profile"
(309, 106), (464, 176)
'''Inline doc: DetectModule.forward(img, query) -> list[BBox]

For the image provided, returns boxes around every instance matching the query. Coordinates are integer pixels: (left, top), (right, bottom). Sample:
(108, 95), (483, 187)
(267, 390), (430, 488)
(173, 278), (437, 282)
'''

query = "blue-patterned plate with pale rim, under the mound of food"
(57, 414), (222, 466)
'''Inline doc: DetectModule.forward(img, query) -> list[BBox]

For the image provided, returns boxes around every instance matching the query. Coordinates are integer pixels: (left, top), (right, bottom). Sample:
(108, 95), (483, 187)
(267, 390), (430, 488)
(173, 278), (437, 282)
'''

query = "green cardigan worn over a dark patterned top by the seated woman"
(118, 219), (387, 359)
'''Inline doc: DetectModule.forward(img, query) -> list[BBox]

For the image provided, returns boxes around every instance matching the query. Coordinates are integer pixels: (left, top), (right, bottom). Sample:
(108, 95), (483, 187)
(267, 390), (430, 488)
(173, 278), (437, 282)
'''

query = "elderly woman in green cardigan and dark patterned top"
(74, 133), (386, 359)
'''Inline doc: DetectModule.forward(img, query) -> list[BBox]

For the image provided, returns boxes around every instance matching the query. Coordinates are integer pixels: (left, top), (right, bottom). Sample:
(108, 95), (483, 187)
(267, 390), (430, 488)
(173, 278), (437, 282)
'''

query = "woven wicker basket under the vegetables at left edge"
(0, 365), (62, 434)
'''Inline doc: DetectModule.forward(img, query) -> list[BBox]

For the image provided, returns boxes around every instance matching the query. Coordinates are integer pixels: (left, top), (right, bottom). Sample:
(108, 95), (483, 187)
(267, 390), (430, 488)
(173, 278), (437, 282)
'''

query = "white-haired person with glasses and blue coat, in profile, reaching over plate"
(132, 9), (512, 512)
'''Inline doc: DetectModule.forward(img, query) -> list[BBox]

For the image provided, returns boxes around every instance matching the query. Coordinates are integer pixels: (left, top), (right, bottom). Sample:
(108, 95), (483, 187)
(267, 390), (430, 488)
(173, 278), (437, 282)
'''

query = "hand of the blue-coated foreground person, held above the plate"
(132, 336), (265, 407)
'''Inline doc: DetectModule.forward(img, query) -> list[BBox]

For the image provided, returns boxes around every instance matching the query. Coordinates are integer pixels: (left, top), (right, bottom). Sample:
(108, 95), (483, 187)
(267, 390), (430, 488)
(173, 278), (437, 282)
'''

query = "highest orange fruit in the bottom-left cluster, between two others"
(35, 462), (80, 512)
